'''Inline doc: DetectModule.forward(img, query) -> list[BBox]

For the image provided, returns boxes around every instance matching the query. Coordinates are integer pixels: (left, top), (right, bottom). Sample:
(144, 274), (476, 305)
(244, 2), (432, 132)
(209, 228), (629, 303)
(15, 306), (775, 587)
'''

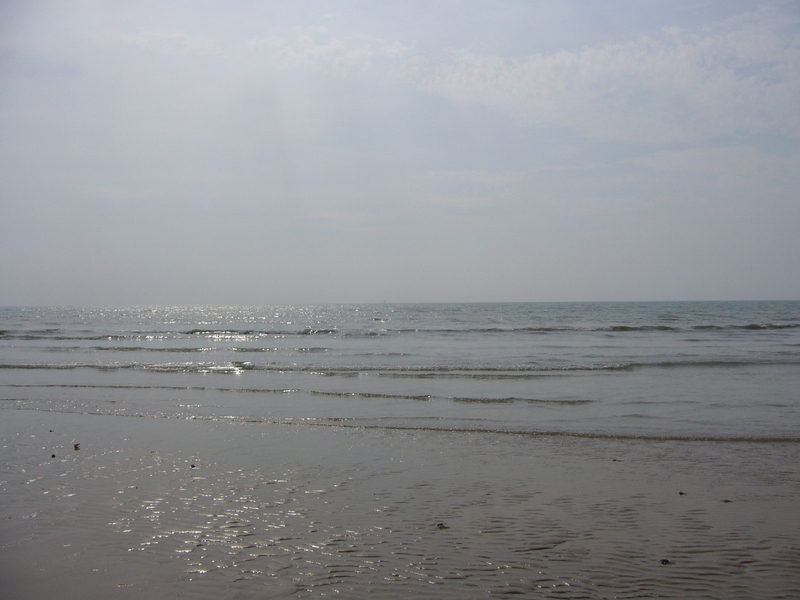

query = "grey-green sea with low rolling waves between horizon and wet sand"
(0, 302), (800, 441)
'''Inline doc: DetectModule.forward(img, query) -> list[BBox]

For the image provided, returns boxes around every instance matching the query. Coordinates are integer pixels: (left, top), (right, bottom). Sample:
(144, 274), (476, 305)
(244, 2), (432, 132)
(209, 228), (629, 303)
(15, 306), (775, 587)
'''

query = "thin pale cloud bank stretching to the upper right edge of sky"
(420, 10), (800, 142)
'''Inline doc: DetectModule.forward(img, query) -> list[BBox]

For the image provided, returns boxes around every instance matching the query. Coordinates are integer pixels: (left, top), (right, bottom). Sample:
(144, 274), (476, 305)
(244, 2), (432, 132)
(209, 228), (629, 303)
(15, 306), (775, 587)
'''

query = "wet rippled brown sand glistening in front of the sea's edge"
(0, 409), (800, 600)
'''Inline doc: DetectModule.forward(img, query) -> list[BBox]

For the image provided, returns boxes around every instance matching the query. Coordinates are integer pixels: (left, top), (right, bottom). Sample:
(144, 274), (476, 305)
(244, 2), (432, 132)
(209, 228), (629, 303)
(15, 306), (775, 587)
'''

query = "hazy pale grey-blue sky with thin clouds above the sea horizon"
(0, 0), (800, 305)
